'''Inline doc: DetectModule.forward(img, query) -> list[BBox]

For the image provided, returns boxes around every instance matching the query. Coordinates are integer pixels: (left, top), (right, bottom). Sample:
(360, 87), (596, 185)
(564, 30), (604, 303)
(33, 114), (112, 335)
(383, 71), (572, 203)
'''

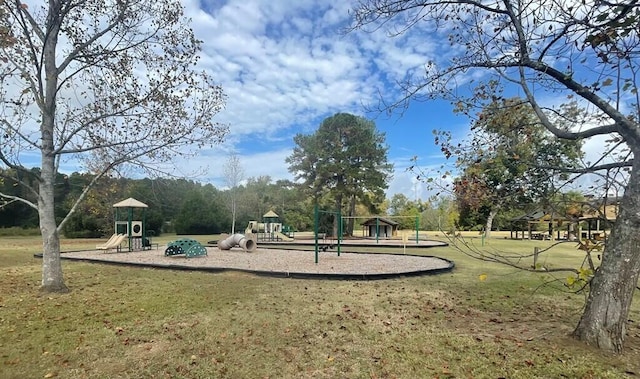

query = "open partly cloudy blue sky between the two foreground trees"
(178, 0), (469, 199)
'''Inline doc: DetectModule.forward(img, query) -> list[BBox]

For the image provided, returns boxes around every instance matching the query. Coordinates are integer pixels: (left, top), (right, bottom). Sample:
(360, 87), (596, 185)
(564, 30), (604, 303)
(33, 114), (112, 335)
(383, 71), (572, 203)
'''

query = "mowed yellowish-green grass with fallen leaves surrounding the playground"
(0, 236), (640, 378)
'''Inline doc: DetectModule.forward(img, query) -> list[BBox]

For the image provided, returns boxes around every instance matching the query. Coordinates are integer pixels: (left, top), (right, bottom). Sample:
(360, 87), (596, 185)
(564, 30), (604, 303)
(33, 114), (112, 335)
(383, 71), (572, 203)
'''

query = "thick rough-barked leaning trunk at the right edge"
(573, 159), (640, 352)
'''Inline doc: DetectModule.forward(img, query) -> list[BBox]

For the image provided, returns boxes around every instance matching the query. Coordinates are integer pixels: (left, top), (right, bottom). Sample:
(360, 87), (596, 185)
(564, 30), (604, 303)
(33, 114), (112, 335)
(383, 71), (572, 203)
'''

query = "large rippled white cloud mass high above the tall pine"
(180, 0), (428, 142)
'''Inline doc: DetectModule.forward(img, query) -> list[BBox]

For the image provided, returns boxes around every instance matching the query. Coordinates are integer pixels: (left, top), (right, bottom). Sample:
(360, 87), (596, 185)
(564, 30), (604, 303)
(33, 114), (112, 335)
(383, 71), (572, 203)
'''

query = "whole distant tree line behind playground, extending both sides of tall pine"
(0, 169), (468, 238)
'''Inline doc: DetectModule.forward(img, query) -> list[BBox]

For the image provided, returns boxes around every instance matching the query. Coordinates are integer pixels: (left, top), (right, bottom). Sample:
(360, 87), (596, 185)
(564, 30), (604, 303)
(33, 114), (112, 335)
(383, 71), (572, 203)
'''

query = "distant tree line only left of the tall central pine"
(0, 169), (313, 238)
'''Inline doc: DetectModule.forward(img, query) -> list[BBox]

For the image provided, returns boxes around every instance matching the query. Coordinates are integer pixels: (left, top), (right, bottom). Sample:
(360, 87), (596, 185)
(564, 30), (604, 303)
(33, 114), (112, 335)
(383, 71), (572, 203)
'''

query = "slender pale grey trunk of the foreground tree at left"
(38, 0), (69, 292)
